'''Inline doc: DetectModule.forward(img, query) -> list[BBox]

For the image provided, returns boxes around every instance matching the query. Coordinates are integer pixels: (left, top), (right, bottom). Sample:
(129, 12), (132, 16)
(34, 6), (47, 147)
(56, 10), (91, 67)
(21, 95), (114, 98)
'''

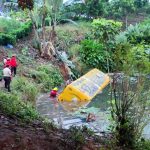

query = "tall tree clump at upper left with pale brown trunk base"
(18, 0), (63, 59)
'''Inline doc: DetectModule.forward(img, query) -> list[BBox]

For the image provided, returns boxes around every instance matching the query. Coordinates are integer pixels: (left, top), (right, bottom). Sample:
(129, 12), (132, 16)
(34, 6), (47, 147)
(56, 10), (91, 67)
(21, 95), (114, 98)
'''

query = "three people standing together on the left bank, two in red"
(3, 54), (17, 92)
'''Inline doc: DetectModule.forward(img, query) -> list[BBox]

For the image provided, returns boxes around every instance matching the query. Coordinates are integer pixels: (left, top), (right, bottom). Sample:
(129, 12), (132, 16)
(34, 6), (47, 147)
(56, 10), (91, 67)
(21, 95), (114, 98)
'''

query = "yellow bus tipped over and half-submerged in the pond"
(58, 69), (110, 105)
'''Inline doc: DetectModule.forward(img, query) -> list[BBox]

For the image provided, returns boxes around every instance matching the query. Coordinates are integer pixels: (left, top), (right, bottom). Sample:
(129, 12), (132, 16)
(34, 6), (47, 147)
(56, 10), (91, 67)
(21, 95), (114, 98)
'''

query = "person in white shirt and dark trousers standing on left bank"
(3, 65), (11, 92)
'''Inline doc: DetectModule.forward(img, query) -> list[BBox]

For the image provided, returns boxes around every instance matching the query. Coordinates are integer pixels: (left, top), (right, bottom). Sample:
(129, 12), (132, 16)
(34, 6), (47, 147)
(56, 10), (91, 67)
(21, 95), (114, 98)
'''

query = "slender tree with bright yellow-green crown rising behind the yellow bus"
(92, 18), (122, 72)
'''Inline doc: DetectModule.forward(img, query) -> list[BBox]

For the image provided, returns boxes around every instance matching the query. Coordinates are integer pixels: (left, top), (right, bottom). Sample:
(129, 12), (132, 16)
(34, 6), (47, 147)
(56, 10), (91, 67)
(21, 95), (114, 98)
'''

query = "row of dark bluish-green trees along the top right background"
(62, 0), (150, 20)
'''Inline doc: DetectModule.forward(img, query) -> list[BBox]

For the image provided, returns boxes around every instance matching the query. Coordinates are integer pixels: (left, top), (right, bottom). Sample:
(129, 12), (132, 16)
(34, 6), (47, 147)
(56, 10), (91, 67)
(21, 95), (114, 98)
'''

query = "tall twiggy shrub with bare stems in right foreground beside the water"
(111, 75), (150, 148)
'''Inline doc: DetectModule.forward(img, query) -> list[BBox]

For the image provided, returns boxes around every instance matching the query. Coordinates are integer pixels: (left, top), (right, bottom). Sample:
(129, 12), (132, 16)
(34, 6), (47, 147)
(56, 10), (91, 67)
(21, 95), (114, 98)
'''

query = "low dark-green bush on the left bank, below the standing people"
(0, 92), (39, 121)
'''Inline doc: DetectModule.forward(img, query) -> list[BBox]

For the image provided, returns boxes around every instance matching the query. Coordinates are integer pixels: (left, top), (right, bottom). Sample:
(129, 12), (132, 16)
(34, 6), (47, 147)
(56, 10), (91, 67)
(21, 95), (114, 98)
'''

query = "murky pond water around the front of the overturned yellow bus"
(36, 87), (150, 139)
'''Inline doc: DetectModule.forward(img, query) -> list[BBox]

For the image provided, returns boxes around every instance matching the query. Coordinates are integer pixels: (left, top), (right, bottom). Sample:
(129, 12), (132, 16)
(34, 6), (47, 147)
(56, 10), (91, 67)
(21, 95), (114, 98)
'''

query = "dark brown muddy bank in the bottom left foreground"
(0, 113), (110, 150)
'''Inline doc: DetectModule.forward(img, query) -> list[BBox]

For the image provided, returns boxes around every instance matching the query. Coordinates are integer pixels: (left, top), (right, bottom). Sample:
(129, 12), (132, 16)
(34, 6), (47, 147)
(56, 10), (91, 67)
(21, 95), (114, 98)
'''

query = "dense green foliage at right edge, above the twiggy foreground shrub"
(114, 20), (150, 73)
